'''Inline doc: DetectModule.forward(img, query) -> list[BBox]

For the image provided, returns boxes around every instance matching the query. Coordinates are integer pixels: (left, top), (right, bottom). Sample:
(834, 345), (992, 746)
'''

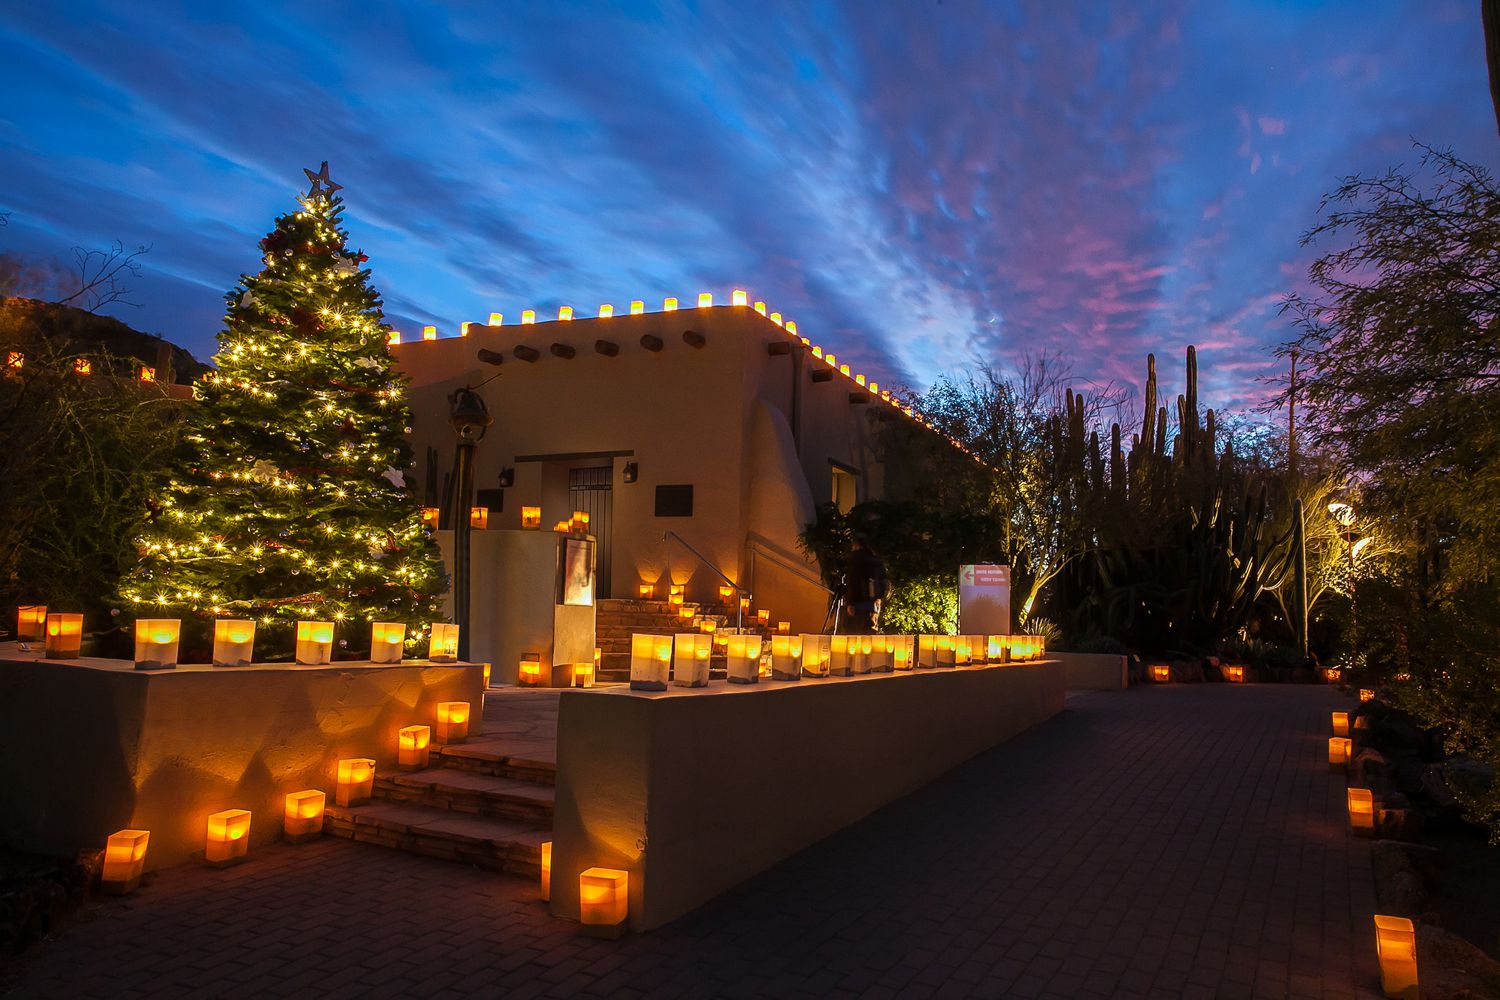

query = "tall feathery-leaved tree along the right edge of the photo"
(1286, 147), (1500, 838)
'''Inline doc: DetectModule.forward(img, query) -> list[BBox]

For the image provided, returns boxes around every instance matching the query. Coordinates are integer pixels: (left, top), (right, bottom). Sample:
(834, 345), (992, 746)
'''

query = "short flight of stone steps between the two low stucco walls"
(323, 695), (557, 879)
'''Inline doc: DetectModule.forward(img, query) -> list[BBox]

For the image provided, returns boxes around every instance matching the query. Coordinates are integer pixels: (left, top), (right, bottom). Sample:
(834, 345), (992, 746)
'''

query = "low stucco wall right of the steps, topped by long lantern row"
(552, 661), (1067, 930)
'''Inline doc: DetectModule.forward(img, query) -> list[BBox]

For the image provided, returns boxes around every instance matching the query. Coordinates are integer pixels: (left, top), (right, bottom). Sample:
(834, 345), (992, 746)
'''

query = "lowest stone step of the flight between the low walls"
(323, 799), (552, 879)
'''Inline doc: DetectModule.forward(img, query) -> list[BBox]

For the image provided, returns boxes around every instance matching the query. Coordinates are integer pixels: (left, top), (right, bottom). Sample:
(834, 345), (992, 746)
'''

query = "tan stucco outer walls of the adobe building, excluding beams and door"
(393, 303), (929, 630)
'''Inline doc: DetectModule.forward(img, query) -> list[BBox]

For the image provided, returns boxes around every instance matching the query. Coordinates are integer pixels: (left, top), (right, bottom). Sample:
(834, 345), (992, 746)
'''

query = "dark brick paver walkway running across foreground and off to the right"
(2, 685), (1377, 1000)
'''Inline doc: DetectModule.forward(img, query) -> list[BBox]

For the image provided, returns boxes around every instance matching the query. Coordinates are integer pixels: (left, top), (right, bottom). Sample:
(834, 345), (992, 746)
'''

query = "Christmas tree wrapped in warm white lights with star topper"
(122, 163), (447, 658)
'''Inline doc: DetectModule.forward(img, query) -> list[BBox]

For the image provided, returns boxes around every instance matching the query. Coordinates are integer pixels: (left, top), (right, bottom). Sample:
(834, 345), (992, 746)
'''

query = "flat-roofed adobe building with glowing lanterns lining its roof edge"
(392, 292), (966, 678)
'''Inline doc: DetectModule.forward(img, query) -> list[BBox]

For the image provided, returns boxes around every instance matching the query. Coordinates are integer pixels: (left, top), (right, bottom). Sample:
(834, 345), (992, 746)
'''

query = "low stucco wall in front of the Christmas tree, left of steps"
(0, 658), (483, 868)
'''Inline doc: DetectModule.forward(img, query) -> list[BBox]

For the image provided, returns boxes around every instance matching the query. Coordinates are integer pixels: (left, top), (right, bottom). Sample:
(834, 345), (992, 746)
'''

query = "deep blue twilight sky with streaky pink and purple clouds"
(0, 0), (1500, 405)
